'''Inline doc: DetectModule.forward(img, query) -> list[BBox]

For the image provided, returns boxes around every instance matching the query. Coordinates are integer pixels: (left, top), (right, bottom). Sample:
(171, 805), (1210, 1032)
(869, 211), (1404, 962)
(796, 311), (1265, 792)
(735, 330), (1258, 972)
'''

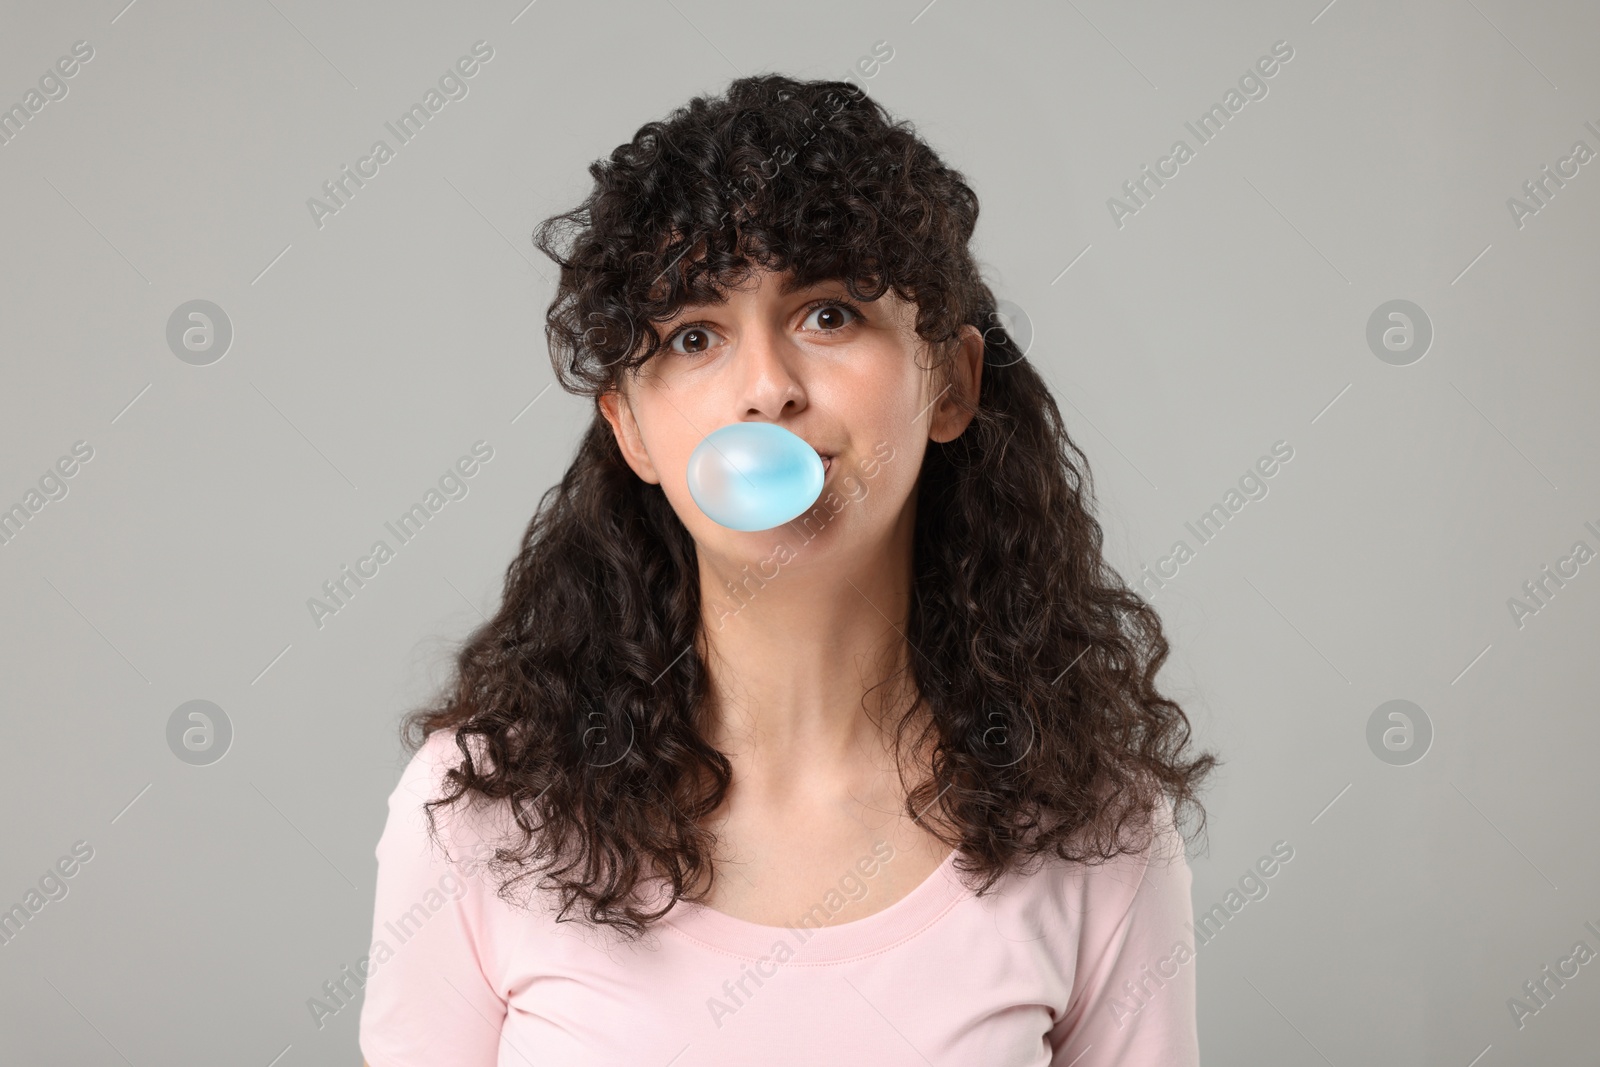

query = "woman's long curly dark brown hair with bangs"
(402, 74), (1218, 936)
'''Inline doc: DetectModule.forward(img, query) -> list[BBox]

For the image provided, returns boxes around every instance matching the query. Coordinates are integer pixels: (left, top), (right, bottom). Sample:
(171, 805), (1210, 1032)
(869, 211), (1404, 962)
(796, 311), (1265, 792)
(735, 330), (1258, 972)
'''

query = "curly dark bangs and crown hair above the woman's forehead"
(536, 75), (984, 395)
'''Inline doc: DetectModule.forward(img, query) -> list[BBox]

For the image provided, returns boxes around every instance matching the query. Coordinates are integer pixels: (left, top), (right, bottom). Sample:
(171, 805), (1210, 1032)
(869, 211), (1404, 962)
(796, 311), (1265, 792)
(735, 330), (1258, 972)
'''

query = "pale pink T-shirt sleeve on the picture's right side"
(1050, 806), (1200, 1067)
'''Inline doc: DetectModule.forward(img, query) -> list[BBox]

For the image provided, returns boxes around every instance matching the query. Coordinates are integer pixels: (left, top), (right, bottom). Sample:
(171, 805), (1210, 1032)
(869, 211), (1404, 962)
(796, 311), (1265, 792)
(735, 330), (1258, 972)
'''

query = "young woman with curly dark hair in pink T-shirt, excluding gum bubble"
(360, 75), (1216, 1067)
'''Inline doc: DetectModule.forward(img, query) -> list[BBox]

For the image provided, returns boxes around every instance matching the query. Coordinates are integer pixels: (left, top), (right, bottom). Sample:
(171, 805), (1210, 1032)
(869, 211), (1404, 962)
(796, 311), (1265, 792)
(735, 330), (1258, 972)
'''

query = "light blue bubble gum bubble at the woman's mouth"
(688, 422), (822, 530)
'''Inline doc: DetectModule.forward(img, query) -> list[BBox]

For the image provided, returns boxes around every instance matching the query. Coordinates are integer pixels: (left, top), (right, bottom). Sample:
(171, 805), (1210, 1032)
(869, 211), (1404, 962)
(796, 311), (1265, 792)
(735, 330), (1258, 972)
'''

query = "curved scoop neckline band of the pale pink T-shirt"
(662, 848), (970, 965)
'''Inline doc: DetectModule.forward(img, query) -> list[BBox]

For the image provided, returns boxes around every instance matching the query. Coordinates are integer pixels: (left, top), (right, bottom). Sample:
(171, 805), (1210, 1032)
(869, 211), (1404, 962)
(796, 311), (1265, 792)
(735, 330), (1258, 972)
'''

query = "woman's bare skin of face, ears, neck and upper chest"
(597, 265), (982, 926)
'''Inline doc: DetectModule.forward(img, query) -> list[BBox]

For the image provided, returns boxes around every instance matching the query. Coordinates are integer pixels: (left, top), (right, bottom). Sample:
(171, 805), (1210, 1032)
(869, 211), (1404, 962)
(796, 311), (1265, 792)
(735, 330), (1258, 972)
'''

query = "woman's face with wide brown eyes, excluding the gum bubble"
(600, 270), (982, 571)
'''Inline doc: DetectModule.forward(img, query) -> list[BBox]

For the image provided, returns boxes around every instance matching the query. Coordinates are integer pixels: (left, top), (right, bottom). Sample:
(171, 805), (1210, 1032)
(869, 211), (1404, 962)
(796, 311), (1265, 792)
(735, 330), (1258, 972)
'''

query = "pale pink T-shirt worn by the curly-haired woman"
(357, 731), (1200, 1067)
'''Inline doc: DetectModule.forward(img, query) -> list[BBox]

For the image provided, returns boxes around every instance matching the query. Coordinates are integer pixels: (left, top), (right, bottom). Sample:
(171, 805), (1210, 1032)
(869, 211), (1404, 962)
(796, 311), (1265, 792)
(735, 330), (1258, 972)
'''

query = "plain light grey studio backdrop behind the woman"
(0, 0), (1600, 1067)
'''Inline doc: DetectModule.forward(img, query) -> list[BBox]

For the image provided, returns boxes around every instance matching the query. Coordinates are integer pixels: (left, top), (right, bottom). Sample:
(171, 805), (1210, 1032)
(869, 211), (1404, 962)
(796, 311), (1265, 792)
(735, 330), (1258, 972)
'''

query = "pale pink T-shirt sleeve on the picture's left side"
(360, 731), (506, 1067)
